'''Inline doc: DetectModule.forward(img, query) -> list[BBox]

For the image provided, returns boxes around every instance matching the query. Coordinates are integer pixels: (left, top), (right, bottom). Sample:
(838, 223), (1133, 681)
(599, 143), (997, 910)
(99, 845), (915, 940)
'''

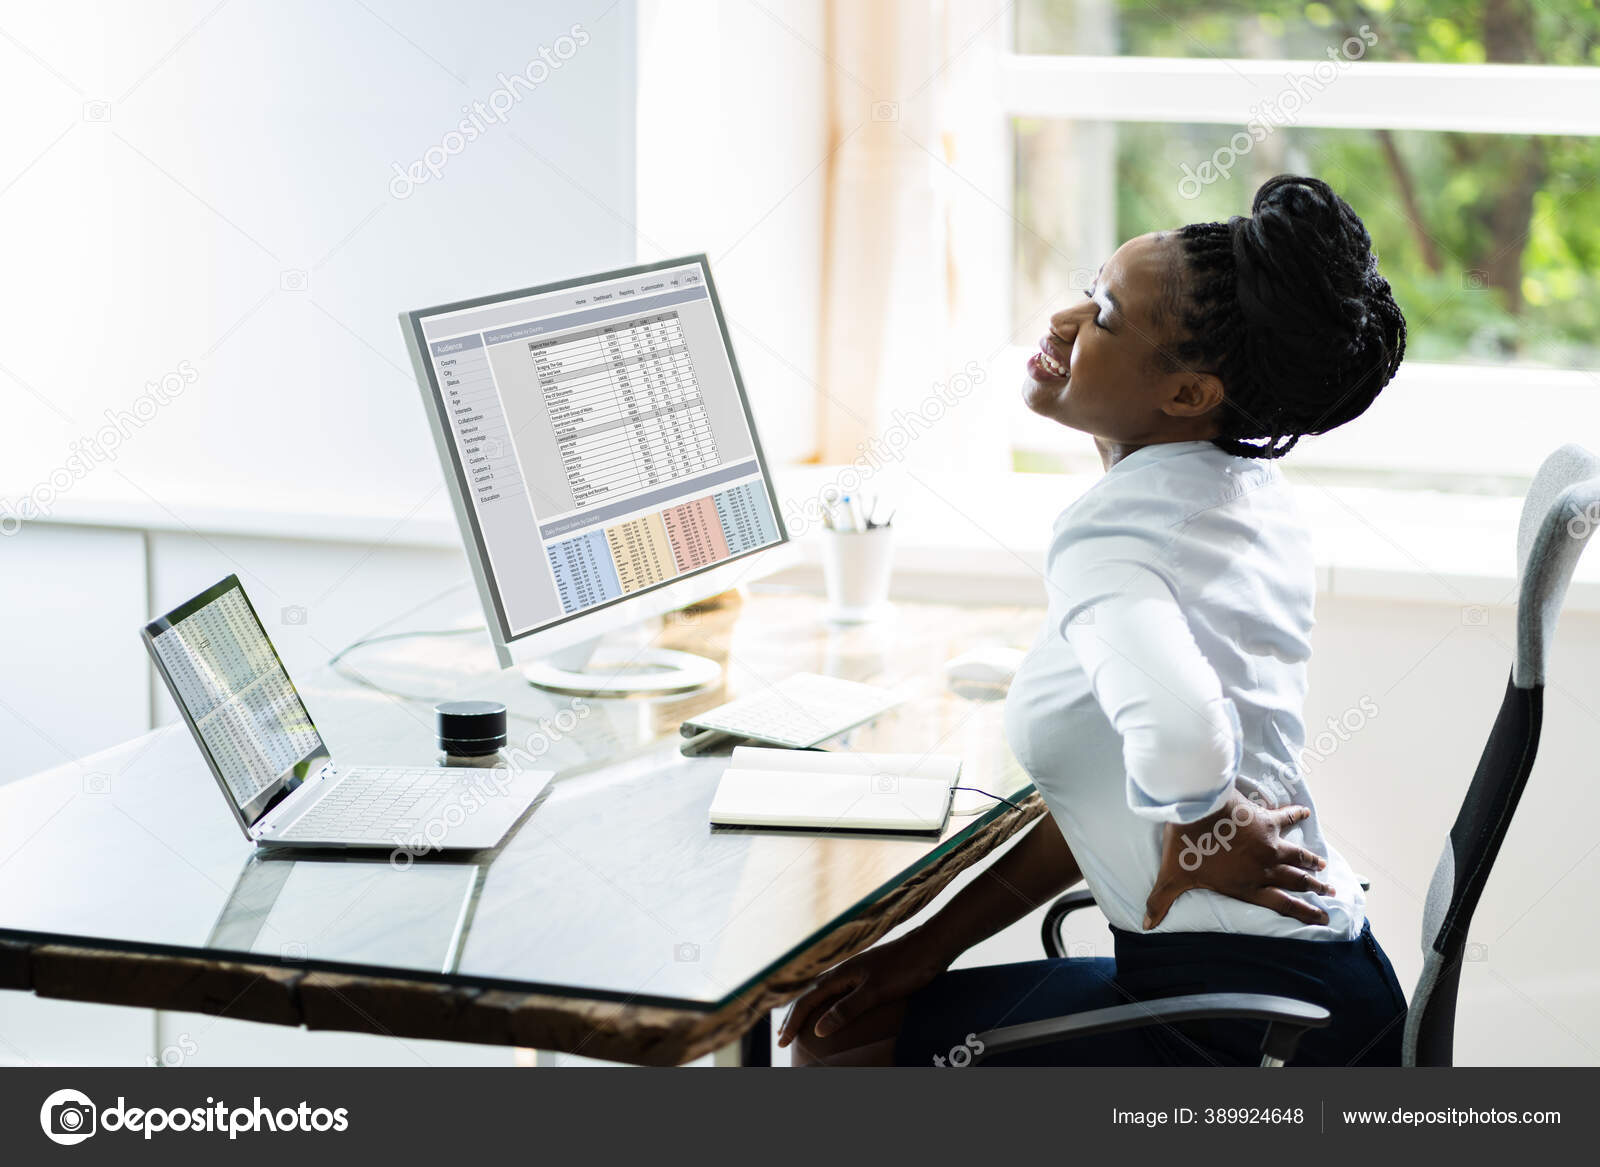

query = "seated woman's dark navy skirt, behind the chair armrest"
(894, 925), (1406, 1066)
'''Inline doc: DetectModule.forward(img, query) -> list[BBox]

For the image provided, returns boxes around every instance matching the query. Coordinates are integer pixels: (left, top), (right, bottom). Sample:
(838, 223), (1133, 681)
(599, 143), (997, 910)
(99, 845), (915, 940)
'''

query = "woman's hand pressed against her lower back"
(1144, 791), (1336, 930)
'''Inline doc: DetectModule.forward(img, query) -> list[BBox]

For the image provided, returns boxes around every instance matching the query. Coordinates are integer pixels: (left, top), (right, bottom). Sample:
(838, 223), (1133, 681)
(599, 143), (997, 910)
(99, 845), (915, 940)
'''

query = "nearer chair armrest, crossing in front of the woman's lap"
(973, 993), (1330, 1065)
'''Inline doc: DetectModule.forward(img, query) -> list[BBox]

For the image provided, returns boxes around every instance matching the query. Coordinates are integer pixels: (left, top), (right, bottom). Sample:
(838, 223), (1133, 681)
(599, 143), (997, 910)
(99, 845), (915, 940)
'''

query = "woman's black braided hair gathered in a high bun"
(1166, 174), (1405, 458)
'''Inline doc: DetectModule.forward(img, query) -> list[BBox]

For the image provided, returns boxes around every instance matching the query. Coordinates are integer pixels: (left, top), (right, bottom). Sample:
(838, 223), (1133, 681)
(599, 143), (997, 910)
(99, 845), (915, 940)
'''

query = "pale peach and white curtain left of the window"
(818, 0), (1014, 469)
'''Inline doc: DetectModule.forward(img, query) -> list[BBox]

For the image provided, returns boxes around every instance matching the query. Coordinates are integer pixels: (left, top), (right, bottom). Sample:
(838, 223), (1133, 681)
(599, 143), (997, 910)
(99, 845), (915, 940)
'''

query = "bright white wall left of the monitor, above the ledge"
(0, 0), (635, 515)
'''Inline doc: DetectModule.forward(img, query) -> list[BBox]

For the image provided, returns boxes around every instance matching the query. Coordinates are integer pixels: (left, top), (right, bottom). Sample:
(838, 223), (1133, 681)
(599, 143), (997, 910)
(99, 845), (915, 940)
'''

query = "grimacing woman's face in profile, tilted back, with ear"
(1022, 232), (1221, 445)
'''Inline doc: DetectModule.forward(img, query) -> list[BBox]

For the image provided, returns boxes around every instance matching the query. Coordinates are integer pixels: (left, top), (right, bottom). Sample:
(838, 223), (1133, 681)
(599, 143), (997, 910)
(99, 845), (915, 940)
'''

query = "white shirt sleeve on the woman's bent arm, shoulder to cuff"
(1051, 536), (1242, 823)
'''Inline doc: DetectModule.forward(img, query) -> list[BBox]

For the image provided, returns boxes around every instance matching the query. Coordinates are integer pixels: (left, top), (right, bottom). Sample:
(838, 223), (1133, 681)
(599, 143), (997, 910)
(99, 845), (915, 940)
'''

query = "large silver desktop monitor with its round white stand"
(400, 256), (789, 695)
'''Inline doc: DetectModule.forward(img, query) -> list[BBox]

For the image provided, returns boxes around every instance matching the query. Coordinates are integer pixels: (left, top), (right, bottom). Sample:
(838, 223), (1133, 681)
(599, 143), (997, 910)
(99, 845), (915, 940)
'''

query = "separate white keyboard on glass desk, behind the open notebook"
(682, 672), (899, 749)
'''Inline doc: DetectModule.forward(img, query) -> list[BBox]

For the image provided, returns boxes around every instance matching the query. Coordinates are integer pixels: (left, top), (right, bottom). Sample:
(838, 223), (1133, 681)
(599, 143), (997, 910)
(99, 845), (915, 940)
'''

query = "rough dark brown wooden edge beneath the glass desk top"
(0, 794), (1043, 1066)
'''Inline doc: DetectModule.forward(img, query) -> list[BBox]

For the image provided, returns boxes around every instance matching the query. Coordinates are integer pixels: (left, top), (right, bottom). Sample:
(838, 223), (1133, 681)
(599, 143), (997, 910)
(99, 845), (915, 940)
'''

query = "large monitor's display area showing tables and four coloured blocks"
(421, 261), (779, 636)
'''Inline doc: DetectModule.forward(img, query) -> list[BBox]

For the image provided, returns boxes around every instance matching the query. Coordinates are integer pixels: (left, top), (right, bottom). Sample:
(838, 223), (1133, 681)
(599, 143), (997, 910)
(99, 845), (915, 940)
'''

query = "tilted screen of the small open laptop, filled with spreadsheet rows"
(144, 576), (326, 828)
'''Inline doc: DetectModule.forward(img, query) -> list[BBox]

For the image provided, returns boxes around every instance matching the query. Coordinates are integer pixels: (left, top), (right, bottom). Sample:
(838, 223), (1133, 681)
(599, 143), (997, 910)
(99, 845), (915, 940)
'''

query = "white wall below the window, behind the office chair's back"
(1307, 600), (1600, 1066)
